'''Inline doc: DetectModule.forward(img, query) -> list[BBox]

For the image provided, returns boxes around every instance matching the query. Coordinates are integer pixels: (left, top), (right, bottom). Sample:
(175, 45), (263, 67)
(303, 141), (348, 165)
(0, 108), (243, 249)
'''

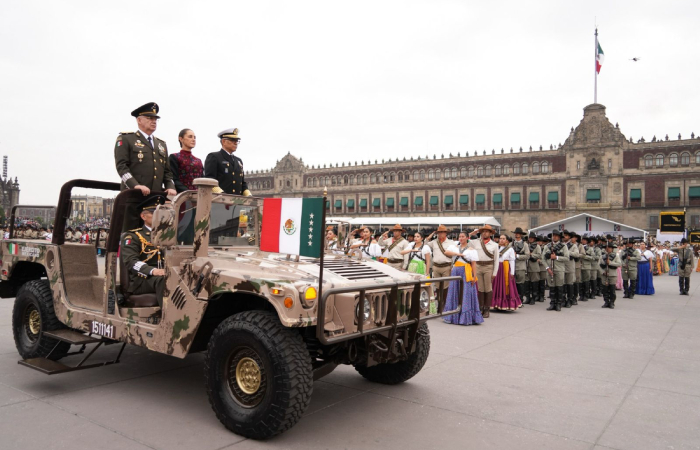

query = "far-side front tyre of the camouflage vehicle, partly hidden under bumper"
(355, 323), (430, 384)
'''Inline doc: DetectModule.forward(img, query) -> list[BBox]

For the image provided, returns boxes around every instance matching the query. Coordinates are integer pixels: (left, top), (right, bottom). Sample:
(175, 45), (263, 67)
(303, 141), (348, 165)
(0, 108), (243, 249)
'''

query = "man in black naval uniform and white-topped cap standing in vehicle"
(204, 128), (253, 197)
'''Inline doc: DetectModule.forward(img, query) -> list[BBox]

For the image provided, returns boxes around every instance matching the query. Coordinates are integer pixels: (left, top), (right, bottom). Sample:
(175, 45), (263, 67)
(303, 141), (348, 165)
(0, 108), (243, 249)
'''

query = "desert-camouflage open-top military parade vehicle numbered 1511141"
(0, 178), (463, 439)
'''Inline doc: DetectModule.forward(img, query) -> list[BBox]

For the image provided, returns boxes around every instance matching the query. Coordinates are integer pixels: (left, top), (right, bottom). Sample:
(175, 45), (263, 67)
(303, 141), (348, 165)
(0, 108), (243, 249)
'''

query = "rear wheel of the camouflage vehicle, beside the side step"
(12, 280), (70, 361)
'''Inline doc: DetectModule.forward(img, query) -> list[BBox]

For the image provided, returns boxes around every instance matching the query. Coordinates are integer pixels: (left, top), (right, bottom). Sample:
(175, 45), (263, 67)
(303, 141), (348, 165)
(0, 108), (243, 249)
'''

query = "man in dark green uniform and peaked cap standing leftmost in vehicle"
(114, 103), (177, 195)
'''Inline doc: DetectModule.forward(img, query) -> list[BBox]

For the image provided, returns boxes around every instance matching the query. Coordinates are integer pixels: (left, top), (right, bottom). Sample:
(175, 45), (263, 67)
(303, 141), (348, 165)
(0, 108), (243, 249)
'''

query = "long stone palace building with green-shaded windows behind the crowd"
(246, 104), (700, 232)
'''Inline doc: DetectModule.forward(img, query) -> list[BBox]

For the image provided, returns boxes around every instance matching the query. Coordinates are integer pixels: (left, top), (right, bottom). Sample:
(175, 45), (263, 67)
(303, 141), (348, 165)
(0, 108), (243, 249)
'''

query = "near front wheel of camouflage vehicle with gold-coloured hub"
(204, 311), (313, 439)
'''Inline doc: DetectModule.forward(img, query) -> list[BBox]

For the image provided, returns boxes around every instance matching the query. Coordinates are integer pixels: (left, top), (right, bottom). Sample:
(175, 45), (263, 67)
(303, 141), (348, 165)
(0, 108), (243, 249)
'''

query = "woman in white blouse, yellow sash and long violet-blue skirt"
(444, 231), (484, 325)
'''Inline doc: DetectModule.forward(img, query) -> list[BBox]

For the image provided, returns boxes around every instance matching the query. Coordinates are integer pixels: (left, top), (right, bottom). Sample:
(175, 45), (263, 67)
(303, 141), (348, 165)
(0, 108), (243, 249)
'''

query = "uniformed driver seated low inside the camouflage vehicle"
(120, 195), (166, 306)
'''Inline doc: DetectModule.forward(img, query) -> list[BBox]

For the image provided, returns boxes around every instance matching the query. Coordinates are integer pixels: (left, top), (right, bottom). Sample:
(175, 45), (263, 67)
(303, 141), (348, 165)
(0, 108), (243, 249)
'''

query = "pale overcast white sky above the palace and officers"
(0, 0), (700, 204)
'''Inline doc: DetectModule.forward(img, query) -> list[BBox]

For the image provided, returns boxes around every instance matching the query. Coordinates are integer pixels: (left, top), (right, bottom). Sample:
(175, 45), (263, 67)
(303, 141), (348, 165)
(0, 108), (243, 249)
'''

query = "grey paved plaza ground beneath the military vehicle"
(0, 273), (700, 450)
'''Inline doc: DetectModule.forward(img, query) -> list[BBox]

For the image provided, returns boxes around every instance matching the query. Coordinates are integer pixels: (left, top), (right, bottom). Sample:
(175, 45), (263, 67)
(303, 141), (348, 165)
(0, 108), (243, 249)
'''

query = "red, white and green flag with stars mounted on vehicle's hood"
(260, 198), (324, 258)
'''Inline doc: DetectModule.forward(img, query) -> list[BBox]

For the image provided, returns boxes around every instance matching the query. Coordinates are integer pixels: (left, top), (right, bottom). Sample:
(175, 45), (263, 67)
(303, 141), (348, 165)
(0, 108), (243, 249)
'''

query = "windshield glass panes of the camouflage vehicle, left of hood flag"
(177, 198), (262, 247)
